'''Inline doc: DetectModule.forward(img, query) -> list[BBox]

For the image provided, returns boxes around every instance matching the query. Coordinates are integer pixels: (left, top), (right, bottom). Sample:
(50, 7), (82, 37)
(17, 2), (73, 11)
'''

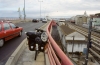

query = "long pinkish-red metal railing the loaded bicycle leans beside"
(46, 20), (73, 65)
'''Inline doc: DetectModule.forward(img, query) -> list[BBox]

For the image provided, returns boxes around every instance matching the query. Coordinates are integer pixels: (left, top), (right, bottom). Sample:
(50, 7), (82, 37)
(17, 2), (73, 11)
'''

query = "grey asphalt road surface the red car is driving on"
(0, 22), (45, 65)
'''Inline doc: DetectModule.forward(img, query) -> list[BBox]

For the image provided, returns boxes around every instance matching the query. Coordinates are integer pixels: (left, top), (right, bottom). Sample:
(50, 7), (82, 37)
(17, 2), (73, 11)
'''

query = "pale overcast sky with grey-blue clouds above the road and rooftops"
(0, 0), (100, 17)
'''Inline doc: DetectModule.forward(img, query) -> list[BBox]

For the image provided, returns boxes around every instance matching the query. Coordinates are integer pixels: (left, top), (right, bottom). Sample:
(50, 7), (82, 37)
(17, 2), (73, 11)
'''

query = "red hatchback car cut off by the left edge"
(0, 21), (23, 47)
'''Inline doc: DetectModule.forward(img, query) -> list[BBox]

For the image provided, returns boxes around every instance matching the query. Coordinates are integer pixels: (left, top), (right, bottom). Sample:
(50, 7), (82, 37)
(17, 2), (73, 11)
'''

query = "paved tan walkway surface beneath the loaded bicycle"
(16, 46), (44, 65)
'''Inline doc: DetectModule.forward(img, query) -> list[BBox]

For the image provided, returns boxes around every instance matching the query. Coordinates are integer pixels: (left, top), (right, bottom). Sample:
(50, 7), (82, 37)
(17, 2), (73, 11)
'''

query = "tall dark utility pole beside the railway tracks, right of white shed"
(85, 18), (92, 65)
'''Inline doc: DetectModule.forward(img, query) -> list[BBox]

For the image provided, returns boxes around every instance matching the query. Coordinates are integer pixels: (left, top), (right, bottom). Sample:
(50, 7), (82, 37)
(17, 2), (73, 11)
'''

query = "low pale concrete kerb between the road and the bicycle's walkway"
(5, 39), (27, 65)
